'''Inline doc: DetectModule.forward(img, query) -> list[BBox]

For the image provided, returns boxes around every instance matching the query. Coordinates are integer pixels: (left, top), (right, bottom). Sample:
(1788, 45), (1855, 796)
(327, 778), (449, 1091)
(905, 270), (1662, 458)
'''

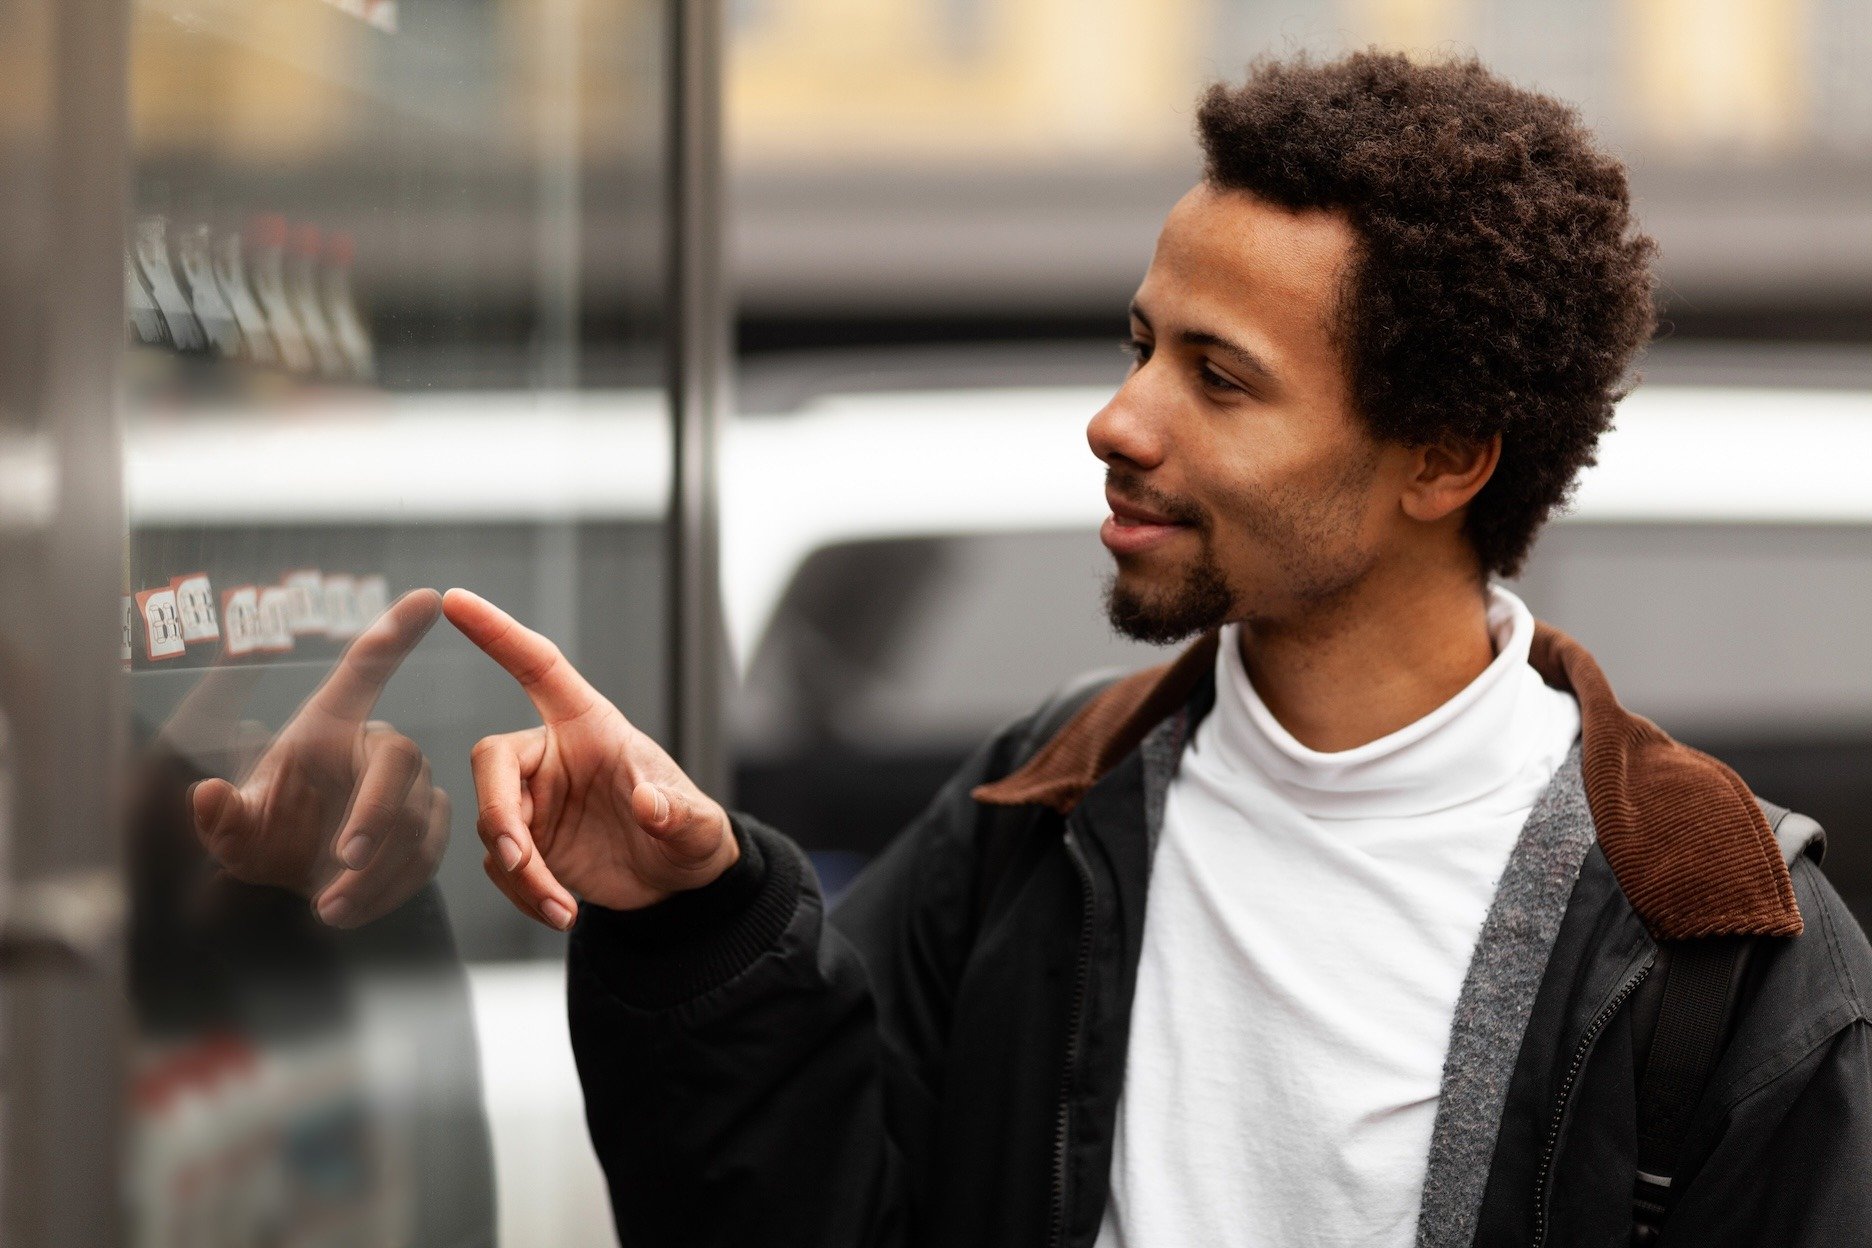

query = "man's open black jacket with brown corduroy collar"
(569, 629), (1872, 1248)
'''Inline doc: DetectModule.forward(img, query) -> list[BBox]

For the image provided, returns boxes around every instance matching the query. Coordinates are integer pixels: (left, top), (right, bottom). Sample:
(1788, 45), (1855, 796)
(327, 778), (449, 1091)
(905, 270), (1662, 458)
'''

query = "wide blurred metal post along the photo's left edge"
(0, 0), (129, 1248)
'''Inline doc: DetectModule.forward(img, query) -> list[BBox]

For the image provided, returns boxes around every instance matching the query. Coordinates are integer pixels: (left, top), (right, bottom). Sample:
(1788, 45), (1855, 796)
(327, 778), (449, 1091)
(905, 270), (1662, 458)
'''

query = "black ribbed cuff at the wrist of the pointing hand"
(571, 814), (803, 1009)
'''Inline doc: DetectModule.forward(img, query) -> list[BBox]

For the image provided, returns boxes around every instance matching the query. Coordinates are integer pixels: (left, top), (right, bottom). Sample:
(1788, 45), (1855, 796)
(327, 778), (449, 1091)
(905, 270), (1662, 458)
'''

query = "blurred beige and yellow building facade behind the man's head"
(728, 0), (1872, 338)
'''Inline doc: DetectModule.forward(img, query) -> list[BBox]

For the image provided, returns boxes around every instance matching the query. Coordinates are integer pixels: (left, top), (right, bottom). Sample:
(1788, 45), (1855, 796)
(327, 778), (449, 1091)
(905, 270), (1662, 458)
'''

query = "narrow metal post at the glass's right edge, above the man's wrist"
(665, 0), (728, 797)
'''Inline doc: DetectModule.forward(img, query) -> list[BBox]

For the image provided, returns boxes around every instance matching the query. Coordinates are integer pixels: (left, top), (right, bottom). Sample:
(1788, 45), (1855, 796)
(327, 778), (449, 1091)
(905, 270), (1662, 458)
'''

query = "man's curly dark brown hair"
(1196, 51), (1657, 576)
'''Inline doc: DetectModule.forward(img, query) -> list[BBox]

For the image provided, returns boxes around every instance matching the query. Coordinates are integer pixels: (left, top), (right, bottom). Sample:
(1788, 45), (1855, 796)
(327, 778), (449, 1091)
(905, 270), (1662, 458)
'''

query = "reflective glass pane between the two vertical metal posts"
(122, 0), (670, 1244)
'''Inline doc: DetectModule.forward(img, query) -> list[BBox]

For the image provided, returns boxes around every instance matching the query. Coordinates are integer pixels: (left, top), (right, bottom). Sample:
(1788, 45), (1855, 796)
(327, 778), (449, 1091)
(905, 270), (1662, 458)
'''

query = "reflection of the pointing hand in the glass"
(189, 589), (449, 928)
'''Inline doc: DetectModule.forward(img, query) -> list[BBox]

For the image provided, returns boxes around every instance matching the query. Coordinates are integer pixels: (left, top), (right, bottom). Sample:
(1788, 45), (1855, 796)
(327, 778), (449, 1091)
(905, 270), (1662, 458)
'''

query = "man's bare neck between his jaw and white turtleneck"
(1241, 553), (1494, 752)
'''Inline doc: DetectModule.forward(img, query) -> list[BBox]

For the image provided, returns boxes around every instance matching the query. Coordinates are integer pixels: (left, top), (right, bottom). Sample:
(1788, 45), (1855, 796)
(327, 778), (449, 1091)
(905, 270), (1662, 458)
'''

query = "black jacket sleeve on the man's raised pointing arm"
(567, 722), (1026, 1248)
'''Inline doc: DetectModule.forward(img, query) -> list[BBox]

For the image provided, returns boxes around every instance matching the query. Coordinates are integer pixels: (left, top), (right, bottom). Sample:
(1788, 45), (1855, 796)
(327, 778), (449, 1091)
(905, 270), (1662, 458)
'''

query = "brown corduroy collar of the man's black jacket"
(973, 625), (1801, 939)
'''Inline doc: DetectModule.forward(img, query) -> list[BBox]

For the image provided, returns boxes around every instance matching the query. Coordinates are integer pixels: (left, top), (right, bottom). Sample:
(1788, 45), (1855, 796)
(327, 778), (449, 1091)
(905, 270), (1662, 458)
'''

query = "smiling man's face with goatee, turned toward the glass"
(1086, 185), (1404, 642)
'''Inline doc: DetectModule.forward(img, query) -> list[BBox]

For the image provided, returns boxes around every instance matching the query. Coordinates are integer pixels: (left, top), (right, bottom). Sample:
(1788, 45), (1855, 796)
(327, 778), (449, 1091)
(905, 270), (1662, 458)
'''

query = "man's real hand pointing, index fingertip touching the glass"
(442, 589), (741, 930)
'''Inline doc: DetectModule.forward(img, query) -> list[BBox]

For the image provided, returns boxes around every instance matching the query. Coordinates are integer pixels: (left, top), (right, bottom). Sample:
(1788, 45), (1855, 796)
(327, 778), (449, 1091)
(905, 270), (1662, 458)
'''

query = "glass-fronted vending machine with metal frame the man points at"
(0, 0), (723, 1248)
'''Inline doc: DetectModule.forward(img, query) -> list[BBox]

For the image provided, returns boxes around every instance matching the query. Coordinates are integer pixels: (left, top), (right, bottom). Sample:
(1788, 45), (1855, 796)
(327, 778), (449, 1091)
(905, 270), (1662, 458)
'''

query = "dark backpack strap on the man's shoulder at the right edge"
(1632, 797), (1827, 1248)
